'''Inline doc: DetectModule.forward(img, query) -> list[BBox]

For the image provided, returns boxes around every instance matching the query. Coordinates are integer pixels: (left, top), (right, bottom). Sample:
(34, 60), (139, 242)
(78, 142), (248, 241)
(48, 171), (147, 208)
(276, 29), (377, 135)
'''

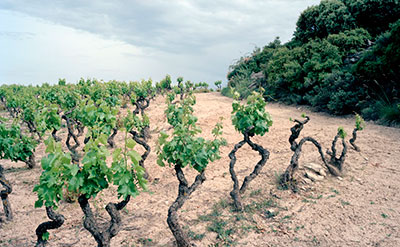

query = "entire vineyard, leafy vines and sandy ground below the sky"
(0, 77), (400, 246)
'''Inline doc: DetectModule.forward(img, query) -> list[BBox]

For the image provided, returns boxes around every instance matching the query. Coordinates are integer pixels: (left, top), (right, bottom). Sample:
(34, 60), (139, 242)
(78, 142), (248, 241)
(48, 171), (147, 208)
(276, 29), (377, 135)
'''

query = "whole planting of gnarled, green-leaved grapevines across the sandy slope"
(0, 76), (364, 246)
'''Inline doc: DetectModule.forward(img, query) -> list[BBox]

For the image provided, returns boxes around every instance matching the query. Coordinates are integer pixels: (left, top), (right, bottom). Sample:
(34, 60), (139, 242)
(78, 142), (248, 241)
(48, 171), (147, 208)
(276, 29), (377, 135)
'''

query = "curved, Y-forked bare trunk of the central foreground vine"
(167, 164), (206, 247)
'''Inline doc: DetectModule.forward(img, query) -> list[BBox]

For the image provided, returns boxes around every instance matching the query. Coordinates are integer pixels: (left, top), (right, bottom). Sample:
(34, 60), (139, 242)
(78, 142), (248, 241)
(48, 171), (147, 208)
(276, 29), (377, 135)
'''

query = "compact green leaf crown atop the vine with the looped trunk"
(232, 92), (272, 136)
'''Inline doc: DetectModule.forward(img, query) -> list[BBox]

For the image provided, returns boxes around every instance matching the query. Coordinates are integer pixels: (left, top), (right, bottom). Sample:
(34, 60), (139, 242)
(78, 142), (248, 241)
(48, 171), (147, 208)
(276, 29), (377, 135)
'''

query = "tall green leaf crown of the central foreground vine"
(157, 94), (225, 172)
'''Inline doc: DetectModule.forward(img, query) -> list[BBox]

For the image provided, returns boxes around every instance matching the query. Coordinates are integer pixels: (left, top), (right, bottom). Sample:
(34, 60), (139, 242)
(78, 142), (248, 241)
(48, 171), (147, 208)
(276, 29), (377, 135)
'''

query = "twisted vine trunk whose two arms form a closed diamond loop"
(229, 131), (269, 211)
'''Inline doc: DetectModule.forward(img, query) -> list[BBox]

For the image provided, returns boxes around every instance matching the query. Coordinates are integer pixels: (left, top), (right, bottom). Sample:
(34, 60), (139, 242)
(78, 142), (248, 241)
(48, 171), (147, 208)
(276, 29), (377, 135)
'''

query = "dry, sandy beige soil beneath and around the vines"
(0, 93), (400, 246)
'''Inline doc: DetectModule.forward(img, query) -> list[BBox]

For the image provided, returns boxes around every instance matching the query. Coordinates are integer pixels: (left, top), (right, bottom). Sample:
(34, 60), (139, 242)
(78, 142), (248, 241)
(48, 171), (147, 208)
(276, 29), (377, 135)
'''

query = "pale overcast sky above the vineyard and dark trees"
(0, 0), (319, 85)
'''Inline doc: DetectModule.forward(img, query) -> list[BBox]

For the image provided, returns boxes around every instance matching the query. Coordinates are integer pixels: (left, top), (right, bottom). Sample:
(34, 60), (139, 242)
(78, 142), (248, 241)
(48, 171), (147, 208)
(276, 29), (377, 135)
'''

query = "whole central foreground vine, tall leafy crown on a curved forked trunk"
(157, 93), (225, 247)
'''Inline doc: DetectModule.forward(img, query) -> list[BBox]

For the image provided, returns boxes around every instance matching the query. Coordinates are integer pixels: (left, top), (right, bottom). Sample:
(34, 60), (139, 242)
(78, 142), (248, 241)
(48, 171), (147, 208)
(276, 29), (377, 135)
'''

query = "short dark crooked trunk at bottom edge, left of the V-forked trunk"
(35, 207), (65, 247)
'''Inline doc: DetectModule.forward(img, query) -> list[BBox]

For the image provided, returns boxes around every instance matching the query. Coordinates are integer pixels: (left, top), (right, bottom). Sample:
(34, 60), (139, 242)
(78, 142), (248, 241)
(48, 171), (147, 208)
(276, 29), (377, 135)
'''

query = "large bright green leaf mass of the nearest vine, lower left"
(33, 124), (147, 207)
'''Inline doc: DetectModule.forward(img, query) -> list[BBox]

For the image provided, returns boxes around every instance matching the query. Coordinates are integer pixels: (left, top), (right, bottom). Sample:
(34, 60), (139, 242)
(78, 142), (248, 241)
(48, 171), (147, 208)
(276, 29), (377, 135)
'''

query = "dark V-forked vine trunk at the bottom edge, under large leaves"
(78, 195), (130, 247)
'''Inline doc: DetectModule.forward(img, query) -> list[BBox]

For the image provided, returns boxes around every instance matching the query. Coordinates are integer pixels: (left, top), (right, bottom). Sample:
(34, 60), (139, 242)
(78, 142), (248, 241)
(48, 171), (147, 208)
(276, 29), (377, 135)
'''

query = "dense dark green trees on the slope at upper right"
(222, 0), (400, 124)
